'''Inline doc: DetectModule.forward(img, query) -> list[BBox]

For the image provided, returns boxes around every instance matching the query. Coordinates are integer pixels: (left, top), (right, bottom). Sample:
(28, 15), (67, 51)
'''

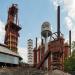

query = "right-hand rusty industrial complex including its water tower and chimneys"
(33, 6), (71, 70)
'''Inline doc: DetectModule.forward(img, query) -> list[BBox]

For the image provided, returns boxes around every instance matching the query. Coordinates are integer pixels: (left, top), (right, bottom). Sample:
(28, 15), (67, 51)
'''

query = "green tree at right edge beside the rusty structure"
(64, 41), (75, 71)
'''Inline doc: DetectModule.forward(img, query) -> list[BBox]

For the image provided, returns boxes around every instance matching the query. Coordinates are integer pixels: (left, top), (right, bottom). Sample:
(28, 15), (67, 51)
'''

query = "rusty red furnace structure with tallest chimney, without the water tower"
(34, 6), (69, 70)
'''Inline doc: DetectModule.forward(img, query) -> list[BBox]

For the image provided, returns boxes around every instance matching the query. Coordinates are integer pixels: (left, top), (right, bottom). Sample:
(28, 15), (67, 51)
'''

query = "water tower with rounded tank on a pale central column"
(41, 22), (52, 67)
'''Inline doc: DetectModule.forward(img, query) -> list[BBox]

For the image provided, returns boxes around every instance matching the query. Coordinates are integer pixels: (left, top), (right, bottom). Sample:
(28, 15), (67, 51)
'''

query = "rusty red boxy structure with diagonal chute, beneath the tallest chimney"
(37, 33), (65, 70)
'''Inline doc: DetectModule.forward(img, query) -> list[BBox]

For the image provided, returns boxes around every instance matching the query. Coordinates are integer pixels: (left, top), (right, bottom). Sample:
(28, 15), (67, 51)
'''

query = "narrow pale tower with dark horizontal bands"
(28, 39), (33, 66)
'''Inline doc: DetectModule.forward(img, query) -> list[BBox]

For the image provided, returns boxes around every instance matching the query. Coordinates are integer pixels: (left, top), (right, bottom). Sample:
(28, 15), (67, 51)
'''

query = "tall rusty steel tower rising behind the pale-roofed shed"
(4, 4), (21, 52)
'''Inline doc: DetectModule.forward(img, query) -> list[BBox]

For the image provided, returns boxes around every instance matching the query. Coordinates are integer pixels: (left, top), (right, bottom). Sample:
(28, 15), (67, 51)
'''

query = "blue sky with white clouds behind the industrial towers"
(0, 0), (75, 62)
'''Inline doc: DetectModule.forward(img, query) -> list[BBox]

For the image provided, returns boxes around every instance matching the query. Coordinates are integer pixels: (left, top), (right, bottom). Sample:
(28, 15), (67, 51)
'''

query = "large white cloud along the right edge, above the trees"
(64, 0), (75, 41)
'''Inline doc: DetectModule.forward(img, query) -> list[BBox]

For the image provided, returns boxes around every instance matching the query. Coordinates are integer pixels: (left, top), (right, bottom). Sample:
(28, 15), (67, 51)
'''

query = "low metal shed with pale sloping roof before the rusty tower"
(0, 44), (22, 66)
